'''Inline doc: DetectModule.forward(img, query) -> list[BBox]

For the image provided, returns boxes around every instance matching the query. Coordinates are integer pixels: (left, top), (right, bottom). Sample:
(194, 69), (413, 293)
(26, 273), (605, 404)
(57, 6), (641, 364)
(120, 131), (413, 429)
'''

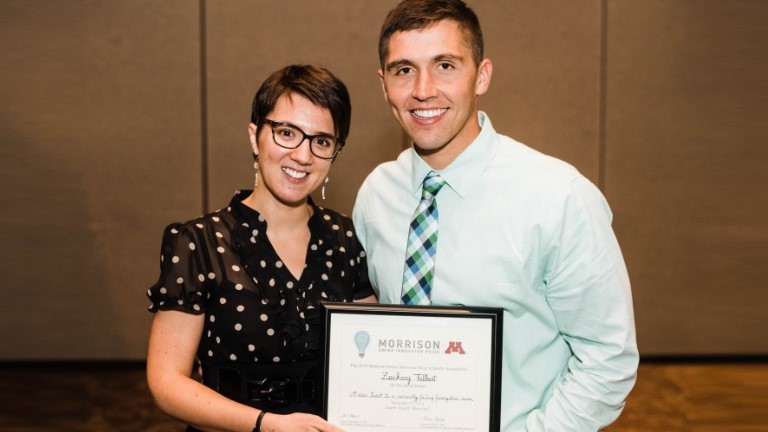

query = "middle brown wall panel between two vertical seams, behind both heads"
(202, 0), (600, 212)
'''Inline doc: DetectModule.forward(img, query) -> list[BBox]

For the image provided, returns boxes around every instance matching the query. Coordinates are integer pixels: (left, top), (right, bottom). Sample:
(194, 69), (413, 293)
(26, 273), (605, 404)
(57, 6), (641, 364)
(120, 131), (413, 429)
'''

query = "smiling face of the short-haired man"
(379, 20), (492, 169)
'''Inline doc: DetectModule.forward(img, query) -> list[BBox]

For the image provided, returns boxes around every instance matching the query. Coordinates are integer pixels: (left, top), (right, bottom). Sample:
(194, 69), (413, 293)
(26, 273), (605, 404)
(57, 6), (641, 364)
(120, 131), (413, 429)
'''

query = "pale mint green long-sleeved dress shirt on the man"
(353, 112), (638, 432)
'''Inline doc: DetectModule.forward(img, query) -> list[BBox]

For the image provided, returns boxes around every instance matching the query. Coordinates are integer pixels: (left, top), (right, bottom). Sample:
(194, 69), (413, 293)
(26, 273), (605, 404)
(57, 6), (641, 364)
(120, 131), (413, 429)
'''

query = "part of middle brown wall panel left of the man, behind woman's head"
(207, 0), (403, 214)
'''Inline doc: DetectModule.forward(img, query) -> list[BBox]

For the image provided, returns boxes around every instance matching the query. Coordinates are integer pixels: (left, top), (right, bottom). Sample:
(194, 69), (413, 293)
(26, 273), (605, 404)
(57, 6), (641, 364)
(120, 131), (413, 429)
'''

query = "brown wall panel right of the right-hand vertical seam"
(606, 0), (768, 355)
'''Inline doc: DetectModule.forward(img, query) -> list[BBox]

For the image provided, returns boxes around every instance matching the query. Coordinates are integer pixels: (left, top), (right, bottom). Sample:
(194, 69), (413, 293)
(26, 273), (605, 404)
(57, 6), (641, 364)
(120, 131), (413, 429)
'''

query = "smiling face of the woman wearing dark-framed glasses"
(248, 93), (336, 206)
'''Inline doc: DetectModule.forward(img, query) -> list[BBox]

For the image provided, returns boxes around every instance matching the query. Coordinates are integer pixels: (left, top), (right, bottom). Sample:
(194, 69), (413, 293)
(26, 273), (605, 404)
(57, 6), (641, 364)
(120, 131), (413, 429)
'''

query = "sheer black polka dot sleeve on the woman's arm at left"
(147, 223), (210, 314)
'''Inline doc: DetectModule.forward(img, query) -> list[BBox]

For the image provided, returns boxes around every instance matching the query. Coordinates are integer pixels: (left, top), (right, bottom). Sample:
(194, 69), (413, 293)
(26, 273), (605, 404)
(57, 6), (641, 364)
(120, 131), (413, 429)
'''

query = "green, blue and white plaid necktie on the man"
(402, 171), (445, 305)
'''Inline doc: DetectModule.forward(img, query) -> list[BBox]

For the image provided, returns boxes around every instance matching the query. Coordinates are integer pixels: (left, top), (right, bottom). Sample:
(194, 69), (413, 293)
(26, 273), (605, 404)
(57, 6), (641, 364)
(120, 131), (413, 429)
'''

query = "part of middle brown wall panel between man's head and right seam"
(470, 0), (601, 183)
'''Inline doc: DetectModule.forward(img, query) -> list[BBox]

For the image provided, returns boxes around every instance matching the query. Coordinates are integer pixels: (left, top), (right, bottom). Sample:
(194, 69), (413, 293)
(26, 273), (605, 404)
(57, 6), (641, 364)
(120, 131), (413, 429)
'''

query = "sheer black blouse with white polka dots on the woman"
(147, 191), (373, 365)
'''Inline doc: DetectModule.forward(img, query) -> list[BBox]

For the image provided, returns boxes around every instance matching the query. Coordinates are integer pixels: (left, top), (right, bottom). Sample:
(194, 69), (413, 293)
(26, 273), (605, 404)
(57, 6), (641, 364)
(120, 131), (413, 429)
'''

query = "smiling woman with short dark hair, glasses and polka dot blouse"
(147, 66), (376, 432)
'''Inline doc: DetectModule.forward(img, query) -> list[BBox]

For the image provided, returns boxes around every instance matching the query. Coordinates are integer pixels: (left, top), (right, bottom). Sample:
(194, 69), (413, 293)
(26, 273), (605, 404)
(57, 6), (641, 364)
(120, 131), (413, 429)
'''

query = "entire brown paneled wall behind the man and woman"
(0, 0), (768, 360)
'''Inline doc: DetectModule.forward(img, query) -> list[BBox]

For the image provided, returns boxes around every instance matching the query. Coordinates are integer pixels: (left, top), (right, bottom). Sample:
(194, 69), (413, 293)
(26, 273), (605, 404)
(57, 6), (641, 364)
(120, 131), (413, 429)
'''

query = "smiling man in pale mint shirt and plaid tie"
(353, 0), (638, 431)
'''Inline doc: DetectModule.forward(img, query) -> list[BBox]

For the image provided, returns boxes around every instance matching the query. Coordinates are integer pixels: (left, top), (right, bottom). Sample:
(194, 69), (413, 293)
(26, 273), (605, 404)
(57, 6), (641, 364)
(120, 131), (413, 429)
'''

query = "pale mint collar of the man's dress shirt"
(411, 111), (496, 197)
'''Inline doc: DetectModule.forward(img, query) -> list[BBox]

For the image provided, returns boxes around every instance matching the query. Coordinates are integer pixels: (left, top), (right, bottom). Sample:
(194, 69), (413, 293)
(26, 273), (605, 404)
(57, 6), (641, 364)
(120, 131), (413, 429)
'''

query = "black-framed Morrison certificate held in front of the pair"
(323, 303), (503, 432)
